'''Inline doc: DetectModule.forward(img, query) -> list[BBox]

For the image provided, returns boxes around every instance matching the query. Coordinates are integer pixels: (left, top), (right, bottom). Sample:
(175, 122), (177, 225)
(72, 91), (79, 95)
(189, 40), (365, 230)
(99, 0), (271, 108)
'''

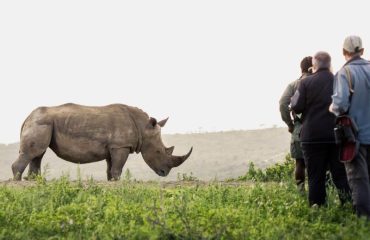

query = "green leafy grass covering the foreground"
(0, 155), (370, 240)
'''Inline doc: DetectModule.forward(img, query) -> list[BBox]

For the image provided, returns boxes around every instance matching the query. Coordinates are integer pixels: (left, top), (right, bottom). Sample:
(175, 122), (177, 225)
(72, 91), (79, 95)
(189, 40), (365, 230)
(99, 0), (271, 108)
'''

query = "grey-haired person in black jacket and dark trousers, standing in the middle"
(291, 52), (350, 206)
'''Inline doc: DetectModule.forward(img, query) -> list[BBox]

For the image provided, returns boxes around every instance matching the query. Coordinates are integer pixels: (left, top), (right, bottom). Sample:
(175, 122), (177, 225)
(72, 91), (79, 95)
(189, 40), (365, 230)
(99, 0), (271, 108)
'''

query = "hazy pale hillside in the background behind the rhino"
(0, 128), (290, 181)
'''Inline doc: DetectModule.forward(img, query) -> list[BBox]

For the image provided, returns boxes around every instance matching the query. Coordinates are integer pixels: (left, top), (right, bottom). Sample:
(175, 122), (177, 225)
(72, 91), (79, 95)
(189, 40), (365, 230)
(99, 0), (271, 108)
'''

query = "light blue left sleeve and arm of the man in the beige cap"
(329, 68), (350, 116)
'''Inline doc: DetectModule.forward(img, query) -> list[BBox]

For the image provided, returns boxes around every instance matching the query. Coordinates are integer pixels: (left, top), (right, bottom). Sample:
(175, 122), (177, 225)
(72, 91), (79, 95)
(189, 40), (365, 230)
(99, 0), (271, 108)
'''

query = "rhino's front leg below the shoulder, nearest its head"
(108, 148), (130, 181)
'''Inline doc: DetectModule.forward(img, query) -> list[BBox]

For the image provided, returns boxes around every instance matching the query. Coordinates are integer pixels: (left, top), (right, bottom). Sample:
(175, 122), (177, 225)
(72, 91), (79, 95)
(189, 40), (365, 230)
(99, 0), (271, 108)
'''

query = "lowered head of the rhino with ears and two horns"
(141, 118), (193, 177)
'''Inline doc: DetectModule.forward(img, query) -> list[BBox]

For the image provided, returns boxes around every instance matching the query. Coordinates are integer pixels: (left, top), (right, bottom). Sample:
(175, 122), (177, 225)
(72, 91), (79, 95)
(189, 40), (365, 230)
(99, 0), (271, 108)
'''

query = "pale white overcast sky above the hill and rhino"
(0, 0), (370, 143)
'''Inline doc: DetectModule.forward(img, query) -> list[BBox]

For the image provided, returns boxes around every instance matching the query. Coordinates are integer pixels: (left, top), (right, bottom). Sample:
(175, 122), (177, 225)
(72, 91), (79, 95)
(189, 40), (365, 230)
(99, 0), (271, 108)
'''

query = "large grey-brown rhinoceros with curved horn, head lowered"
(12, 103), (193, 180)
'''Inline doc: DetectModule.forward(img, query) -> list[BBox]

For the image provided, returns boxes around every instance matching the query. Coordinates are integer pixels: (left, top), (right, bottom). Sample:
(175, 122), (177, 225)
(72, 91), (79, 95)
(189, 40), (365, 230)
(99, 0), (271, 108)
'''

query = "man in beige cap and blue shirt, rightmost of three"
(330, 36), (370, 220)
